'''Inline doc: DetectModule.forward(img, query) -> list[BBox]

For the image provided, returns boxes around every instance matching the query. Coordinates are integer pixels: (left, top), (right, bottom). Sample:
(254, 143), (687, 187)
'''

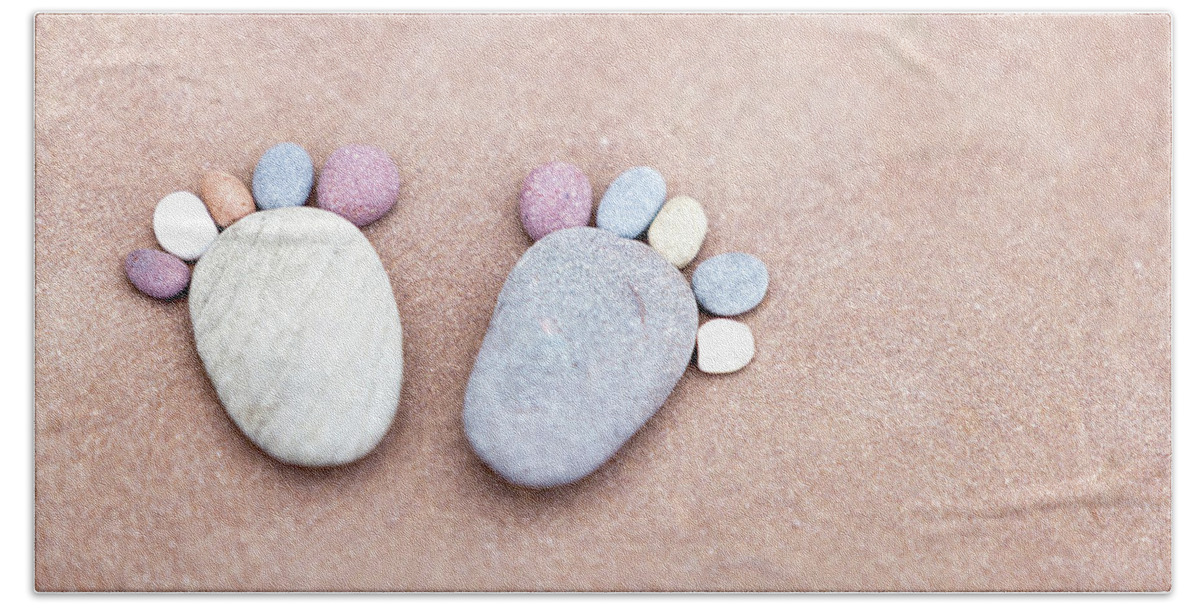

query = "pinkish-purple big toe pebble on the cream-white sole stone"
(317, 144), (400, 228)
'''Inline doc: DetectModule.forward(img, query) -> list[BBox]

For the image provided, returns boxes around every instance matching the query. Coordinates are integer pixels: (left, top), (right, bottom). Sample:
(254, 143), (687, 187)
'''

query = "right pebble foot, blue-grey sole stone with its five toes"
(463, 162), (768, 488)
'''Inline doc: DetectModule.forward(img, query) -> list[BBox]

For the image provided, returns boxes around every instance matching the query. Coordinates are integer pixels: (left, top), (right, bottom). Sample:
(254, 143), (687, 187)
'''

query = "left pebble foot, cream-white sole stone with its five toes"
(125, 143), (403, 466)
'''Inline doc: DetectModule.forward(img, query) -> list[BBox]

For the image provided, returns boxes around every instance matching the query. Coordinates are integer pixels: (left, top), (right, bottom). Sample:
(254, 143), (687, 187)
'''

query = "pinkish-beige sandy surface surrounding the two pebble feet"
(35, 14), (1171, 590)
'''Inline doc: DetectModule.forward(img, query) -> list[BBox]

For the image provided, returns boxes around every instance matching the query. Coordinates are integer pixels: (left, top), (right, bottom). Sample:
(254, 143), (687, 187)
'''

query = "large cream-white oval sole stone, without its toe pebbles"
(188, 207), (403, 466)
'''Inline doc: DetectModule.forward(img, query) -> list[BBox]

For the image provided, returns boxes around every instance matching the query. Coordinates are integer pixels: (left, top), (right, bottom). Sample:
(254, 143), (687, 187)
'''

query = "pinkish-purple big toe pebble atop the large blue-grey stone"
(520, 162), (592, 241)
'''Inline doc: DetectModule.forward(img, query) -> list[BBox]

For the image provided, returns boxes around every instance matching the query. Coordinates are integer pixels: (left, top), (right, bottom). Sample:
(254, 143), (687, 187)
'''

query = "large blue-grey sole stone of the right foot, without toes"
(462, 227), (698, 488)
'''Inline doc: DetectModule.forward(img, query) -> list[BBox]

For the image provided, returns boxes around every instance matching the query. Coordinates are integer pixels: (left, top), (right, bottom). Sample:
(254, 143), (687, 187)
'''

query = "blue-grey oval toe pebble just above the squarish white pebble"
(691, 253), (768, 317)
